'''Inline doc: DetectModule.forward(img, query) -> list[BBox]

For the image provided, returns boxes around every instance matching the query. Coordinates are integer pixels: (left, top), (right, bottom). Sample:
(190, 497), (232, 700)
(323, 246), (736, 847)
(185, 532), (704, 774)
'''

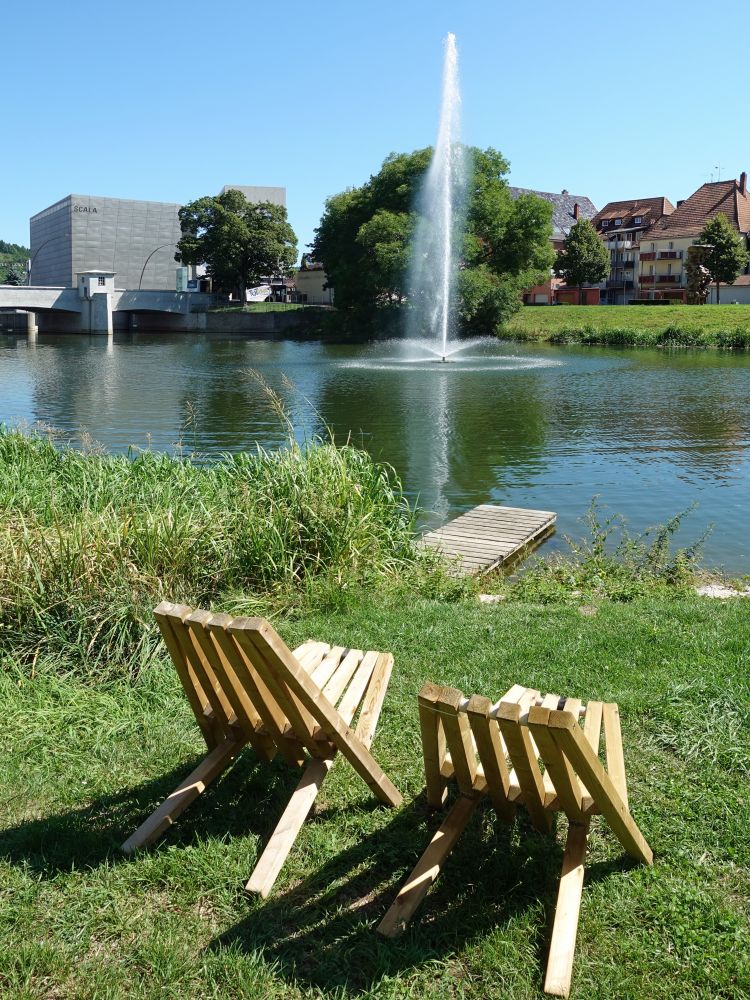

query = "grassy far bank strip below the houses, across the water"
(499, 304), (750, 350)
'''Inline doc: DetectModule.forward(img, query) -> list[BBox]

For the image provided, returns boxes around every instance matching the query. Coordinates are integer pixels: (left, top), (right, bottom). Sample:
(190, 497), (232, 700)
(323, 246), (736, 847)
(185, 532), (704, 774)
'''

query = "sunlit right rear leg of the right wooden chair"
(544, 823), (589, 997)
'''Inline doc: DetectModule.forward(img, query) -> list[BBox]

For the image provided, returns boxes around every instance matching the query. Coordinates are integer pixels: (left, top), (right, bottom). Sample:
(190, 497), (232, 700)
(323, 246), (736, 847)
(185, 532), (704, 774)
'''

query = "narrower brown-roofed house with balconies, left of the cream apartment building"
(591, 197), (675, 305)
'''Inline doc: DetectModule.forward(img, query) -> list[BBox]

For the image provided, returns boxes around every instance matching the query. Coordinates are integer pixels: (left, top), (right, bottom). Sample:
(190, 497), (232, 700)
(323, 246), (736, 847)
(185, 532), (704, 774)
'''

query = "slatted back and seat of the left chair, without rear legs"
(154, 601), (401, 802)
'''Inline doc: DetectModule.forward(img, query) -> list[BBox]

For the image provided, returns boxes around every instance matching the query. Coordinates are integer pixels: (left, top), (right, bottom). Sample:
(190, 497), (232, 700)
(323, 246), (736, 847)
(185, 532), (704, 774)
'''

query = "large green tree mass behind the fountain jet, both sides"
(312, 149), (554, 333)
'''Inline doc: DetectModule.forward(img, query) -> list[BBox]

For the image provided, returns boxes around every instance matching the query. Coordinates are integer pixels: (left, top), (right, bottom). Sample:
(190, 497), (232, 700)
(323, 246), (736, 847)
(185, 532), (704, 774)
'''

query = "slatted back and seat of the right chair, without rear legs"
(419, 683), (651, 863)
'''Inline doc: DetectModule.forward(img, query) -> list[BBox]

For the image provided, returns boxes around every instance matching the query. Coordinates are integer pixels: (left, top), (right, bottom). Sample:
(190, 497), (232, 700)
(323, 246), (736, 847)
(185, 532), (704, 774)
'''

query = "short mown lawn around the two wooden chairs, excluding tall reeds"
(0, 588), (750, 1000)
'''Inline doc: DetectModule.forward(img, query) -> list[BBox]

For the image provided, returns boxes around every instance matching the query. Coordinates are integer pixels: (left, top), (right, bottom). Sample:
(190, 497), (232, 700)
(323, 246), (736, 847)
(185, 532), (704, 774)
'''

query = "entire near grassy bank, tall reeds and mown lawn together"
(0, 433), (750, 1000)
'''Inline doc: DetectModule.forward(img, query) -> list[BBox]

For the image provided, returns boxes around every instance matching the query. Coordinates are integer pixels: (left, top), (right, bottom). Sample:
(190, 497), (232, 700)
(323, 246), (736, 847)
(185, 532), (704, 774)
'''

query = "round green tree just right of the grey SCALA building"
(175, 190), (297, 303)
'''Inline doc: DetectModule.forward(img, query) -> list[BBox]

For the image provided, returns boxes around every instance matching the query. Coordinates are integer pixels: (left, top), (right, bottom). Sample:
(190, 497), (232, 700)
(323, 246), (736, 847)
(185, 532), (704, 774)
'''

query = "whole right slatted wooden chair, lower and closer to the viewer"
(378, 683), (653, 997)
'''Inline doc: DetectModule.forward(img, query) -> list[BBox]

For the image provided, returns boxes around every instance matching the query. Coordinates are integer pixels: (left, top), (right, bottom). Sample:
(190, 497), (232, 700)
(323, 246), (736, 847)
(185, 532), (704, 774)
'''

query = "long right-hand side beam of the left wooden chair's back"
(230, 618), (403, 806)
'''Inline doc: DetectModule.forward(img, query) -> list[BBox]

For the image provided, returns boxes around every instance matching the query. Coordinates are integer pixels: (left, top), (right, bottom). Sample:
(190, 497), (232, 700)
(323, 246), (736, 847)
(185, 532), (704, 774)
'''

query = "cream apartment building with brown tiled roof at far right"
(638, 171), (750, 302)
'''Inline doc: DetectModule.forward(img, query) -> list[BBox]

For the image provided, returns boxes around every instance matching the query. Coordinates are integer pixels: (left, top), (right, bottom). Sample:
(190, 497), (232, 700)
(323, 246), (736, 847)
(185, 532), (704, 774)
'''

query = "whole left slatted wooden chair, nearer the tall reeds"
(122, 602), (402, 897)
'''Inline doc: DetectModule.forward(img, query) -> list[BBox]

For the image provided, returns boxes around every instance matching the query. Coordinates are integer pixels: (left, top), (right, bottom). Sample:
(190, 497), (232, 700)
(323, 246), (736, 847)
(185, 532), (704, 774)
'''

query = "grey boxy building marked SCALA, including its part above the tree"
(29, 185), (286, 290)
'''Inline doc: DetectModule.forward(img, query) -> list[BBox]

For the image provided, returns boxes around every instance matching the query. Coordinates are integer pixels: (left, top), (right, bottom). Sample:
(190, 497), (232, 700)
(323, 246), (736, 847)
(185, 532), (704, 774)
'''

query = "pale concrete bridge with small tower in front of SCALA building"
(0, 285), (223, 335)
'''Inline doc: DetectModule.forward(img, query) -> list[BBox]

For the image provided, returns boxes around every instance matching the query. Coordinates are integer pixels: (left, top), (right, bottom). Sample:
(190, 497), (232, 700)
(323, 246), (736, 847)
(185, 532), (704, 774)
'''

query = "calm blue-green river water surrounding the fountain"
(0, 334), (750, 573)
